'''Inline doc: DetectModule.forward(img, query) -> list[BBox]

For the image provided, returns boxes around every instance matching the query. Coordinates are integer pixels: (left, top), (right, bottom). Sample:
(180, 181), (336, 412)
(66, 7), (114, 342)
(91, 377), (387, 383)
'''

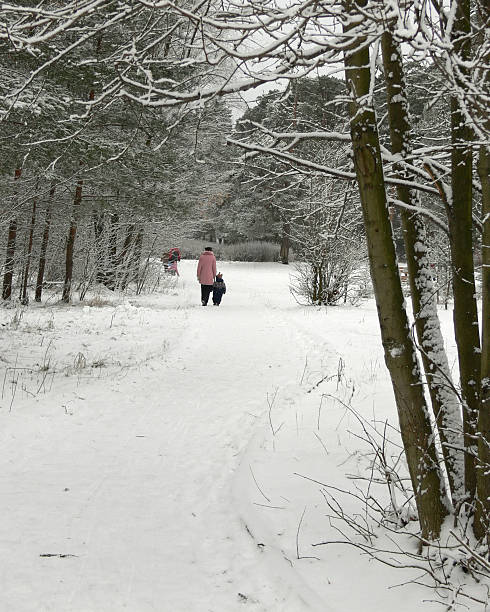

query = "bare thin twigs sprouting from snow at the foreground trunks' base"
(297, 406), (490, 611)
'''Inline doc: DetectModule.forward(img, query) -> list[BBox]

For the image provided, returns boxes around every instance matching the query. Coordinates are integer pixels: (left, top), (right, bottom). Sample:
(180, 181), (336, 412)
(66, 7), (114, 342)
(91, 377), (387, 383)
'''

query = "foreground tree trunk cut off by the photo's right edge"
(474, 146), (490, 548)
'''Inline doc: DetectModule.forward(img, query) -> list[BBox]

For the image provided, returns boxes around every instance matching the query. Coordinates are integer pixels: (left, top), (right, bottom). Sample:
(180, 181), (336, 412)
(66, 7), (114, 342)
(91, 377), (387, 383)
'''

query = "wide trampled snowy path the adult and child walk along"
(0, 265), (330, 612)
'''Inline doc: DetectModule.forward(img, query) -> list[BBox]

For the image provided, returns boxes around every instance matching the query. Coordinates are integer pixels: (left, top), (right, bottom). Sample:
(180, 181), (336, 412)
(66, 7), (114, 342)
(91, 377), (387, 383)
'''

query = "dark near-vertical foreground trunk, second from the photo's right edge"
(447, 0), (481, 503)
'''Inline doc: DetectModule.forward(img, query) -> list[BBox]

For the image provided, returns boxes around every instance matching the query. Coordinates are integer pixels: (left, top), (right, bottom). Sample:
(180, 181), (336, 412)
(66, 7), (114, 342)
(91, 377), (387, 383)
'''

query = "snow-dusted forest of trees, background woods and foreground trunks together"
(0, 0), (490, 610)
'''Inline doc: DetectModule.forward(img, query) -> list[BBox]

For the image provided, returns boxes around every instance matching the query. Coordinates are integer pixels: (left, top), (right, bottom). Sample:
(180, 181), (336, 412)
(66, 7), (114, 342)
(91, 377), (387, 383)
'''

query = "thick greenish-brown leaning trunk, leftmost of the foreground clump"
(344, 0), (447, 539)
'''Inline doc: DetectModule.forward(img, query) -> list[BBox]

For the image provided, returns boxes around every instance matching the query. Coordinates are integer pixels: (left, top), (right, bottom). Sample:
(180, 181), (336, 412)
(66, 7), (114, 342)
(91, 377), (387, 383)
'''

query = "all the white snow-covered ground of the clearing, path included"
(0, 262), (482, 612)
